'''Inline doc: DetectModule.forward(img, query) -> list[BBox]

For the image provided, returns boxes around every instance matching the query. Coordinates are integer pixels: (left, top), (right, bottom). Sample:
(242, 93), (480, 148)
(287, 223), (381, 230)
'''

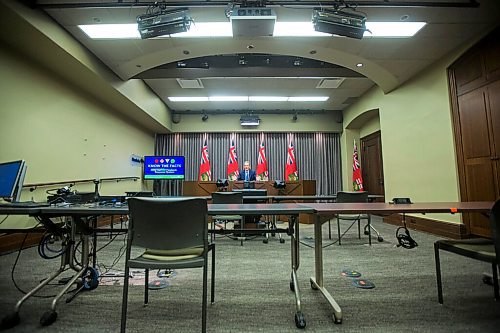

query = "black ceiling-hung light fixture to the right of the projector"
(312, 9), (366, 39)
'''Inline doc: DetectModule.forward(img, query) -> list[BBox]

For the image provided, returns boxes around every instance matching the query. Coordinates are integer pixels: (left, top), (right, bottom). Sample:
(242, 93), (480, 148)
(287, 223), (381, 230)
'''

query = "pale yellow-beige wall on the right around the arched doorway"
(342, 50), (459, 222)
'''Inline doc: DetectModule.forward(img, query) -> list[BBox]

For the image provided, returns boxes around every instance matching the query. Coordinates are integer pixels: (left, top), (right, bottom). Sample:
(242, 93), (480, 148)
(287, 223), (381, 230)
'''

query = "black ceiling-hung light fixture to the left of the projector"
(137, 8), (192, 39)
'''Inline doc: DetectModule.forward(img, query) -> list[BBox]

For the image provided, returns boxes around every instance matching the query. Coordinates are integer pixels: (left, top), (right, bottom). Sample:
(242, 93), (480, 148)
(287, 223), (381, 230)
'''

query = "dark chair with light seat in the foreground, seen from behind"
(121, 198), (215, 333)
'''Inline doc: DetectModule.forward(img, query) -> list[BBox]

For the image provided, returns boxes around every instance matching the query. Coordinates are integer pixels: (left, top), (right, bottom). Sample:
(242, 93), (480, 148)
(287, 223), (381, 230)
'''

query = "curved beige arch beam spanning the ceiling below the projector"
(115, 38), (400, 93)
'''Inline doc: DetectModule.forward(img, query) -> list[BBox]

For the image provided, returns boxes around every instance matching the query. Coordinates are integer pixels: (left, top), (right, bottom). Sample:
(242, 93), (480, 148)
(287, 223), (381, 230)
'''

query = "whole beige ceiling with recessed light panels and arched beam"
(36, 0), (500, 114)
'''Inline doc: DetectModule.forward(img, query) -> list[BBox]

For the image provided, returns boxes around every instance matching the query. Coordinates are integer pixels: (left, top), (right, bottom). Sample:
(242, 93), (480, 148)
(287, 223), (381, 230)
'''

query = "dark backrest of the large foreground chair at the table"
(128, 198), (208, 250)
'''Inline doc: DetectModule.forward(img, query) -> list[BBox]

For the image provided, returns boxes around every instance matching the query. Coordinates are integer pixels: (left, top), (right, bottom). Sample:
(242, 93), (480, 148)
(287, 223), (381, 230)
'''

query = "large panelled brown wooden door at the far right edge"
(448, 27), (500, 237)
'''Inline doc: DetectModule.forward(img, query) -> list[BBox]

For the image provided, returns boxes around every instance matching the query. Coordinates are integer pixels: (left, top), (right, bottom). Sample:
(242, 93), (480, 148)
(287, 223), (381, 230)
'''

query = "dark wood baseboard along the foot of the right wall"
(383, 214), (468, 239)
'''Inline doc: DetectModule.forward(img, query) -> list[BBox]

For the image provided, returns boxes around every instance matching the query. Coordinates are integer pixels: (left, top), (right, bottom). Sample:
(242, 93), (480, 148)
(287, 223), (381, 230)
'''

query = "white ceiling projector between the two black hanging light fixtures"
(230, 7), (276, 37)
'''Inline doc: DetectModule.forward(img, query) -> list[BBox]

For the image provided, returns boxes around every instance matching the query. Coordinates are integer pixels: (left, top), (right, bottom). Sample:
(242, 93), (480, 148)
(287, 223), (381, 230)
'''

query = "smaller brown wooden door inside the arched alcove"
(361, 131), (385, 202)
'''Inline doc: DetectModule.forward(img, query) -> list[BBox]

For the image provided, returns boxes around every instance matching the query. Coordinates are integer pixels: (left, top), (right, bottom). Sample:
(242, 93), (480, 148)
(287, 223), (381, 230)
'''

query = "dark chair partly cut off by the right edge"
(434, 199), (500, 304)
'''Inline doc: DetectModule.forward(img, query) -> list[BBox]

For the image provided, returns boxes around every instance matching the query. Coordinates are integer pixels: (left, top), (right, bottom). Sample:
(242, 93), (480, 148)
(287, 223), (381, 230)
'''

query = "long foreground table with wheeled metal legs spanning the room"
(0, 198), (493, 328)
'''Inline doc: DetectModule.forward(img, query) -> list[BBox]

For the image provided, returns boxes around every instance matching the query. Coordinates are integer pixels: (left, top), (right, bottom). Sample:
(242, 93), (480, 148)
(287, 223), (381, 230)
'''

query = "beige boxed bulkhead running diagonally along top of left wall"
(0, 0), (171, 133)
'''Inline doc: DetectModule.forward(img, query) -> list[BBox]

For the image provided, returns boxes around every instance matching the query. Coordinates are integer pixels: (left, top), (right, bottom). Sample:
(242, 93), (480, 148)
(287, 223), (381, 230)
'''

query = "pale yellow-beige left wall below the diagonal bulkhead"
(0, 49), (154, 228)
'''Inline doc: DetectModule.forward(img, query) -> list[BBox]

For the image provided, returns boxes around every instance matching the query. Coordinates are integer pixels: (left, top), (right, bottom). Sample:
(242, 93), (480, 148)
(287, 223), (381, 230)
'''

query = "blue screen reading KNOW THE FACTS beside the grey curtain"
(144, 156), (185, 179)
